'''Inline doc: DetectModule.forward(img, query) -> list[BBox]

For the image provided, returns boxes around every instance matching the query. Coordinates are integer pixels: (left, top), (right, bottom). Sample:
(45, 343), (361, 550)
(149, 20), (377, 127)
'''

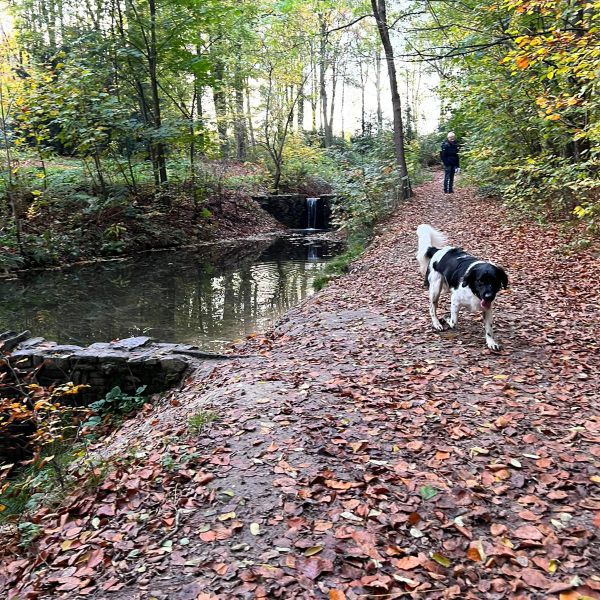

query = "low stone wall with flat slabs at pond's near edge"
(0, 332), (228, 404)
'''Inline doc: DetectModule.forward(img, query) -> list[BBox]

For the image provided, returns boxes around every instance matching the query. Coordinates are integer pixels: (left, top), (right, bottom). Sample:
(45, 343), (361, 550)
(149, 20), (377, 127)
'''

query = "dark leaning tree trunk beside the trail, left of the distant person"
(371, 0), (412, 198)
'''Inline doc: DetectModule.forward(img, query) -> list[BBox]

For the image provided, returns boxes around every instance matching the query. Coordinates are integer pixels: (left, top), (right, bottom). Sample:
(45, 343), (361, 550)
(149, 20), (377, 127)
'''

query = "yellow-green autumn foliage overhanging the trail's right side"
(422, 0), (600, 233)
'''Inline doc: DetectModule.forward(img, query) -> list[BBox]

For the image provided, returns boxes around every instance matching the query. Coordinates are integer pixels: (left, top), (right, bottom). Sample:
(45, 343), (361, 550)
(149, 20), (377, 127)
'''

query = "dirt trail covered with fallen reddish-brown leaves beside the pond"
(0, 177), (600, 600)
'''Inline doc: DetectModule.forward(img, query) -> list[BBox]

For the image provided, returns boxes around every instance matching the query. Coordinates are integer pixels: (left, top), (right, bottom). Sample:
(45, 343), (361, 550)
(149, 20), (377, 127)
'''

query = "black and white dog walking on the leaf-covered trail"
(417, 225), (508, 350)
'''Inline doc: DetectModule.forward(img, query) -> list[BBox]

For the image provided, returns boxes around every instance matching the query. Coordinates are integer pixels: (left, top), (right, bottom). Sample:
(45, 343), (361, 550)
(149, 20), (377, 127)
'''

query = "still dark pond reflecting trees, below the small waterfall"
(0, 233), (341, 350)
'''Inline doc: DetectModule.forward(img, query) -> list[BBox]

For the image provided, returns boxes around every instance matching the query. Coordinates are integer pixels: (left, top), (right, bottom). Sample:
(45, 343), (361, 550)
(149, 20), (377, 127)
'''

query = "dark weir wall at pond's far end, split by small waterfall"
(254, 194), (334, 229)
